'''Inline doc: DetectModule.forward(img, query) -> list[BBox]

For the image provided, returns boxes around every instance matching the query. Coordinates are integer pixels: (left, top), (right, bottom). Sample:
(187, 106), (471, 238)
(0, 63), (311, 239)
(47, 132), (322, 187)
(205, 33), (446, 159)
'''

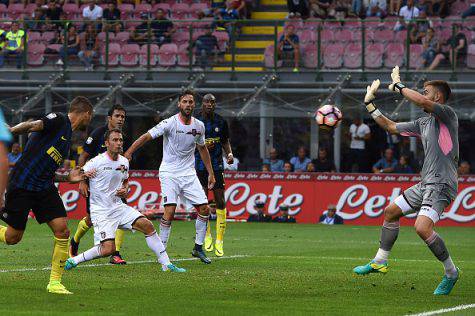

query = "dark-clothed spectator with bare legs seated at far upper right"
(428, 24), (468, 70)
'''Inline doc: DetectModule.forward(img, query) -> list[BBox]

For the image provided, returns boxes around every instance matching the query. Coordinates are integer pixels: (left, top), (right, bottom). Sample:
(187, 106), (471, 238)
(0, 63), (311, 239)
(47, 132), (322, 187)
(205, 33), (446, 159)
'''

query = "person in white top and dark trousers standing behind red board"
(348, 117), (371, 172)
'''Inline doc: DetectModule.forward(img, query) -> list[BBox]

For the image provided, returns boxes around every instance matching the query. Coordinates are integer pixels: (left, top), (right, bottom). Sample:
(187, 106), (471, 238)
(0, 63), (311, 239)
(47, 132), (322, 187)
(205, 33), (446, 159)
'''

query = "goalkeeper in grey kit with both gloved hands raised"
(354, 66), (459, 295)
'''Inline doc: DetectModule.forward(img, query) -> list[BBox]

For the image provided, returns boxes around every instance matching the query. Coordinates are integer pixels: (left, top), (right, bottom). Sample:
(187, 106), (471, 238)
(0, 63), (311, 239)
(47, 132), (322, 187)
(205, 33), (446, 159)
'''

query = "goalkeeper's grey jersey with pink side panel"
(396, 104), (459, 194)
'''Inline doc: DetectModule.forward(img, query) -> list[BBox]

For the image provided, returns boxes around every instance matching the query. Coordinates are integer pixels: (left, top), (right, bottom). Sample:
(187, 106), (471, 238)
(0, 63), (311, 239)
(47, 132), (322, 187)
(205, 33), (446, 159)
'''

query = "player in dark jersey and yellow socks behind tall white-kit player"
(195, 94), (234, 257)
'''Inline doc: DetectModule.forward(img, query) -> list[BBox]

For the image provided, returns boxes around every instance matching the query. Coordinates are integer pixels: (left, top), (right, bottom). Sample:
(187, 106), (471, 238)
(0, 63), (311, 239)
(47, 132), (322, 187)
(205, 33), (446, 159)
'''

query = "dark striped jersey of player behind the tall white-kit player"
(195, 112), (229, 171)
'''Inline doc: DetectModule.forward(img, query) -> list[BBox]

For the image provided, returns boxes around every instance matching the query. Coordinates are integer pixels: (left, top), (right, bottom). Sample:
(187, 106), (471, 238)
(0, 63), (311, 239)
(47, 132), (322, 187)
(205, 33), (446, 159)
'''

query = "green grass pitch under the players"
(0, 221), (475, 315)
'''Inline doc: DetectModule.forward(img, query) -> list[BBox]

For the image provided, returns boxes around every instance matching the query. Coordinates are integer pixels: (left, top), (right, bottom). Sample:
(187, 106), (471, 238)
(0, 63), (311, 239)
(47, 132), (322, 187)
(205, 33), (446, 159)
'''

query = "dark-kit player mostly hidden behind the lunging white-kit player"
(69, 104), (127, 264)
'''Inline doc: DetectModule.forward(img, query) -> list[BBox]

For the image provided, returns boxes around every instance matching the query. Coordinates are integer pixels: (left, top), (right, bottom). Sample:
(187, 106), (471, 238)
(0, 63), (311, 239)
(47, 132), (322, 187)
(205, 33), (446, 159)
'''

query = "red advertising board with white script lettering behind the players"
(59, 171), (475, 226)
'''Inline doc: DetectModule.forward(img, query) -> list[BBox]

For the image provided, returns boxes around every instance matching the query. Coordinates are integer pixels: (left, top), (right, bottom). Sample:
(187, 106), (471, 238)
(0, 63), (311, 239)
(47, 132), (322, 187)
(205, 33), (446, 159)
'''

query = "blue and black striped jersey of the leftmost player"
(8, 112), (73, 191)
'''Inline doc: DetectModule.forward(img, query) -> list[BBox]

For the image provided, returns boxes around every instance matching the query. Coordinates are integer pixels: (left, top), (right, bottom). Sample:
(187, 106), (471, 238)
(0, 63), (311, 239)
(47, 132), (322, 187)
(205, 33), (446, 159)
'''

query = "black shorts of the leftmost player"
(0, 187), (67, 230)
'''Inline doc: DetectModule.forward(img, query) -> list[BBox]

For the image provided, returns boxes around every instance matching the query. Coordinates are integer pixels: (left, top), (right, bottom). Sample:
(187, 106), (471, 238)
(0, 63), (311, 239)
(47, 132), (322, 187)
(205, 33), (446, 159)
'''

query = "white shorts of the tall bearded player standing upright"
(159, 173), (208, 206)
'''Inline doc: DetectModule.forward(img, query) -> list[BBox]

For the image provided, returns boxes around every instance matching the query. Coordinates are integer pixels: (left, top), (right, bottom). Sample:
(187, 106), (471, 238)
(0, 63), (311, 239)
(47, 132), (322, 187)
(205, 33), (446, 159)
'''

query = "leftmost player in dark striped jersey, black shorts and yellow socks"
(0, 97), (92, 294)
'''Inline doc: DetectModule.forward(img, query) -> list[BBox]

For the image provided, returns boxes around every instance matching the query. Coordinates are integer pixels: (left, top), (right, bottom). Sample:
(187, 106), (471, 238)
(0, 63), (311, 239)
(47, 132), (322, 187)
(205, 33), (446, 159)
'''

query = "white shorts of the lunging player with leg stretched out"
(91, 204), (144, 245)
